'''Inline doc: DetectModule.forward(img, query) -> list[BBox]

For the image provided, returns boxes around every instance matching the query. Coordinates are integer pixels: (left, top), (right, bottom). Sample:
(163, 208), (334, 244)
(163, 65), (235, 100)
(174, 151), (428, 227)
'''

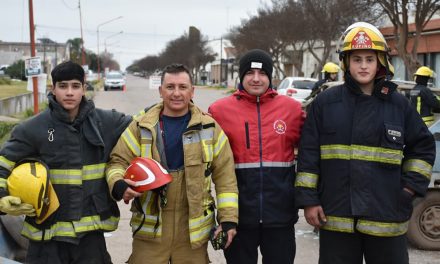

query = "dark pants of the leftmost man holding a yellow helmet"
(26, 232), (112, 264)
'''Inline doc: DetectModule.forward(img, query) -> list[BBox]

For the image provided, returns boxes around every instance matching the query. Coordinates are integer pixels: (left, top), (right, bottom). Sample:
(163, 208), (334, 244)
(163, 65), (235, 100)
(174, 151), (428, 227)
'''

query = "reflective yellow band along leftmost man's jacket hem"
(21, 216), (119, 241)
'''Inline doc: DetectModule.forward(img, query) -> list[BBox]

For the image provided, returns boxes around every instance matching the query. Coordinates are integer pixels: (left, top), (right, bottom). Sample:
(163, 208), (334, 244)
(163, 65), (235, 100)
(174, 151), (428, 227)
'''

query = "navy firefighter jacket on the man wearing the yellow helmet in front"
(295, 75), (435, 237)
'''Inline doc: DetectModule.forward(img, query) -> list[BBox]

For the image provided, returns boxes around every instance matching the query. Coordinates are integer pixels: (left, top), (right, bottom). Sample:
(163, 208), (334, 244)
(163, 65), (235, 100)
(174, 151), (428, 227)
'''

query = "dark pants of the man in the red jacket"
(224, 226), (296, 264)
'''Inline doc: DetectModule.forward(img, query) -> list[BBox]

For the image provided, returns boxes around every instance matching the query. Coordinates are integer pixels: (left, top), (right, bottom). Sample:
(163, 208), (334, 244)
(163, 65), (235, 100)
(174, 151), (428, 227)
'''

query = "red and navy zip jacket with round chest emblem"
(209, 89), (304, 228)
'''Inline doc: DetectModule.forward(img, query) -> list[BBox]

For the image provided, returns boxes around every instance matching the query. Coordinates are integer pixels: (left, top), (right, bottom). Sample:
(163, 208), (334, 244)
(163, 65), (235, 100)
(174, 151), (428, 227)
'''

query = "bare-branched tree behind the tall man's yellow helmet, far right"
(377, 0), (440, 76)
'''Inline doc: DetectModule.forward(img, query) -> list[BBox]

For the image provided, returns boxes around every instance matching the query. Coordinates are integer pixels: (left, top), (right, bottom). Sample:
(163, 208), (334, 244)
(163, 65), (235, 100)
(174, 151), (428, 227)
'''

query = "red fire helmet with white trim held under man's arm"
(124, 157), (173, 192)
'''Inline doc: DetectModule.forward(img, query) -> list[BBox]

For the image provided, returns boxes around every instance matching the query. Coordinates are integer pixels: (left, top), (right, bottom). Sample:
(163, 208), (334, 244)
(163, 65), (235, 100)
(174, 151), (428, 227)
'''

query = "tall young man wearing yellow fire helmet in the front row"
(295, 22), (435, 264)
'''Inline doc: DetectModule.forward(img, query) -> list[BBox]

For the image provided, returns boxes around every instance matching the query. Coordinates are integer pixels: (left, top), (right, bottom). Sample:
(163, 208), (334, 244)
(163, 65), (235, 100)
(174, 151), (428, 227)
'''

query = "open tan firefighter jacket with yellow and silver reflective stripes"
(106, 103), (238, 248)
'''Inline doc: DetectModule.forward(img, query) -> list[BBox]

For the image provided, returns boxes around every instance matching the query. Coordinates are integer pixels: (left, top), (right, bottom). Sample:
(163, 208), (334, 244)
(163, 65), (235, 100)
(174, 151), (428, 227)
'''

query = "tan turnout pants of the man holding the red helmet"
(128, 171), (209, 264)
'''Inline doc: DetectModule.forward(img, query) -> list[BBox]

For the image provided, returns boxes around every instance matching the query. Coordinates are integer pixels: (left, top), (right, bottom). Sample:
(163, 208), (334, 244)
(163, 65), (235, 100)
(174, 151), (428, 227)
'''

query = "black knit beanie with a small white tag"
(238, 49), (273, 87)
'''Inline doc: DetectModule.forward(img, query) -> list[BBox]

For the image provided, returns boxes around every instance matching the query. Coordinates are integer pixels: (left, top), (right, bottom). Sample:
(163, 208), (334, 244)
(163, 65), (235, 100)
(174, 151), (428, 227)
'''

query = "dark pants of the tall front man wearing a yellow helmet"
(319, 229), (409, 264)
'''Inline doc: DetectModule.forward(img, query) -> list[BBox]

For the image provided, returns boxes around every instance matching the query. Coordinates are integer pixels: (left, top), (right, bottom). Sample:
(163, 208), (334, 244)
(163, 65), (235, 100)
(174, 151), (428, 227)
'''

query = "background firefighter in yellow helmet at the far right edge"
(410, 66), (440, 127)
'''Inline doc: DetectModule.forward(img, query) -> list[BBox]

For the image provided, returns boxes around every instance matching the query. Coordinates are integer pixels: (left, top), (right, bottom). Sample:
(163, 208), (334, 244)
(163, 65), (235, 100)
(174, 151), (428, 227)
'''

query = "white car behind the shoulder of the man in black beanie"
(277, 77), (318, 103)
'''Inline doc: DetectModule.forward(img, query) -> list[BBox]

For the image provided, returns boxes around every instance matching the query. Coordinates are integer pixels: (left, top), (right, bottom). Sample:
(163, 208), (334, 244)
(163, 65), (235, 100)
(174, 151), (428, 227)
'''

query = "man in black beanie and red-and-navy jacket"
(209, 50), (304, 264)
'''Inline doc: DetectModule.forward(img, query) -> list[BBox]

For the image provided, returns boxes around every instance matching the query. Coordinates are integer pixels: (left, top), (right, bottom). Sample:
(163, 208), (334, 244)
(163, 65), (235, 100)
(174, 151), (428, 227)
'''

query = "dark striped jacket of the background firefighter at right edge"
(410, 84), (440, 127)
